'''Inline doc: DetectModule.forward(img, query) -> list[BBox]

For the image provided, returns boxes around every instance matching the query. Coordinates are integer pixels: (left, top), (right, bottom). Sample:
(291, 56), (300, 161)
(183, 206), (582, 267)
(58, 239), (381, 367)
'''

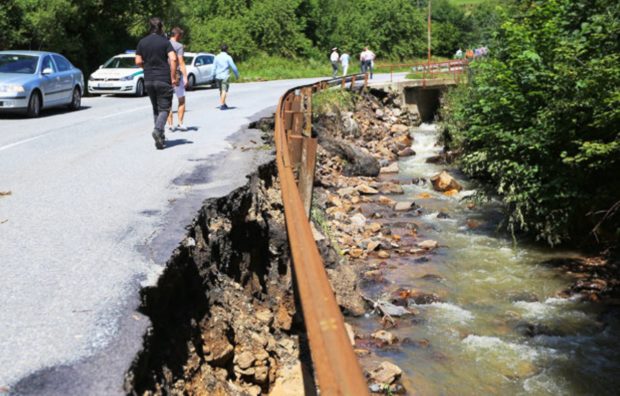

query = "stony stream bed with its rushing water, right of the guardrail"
(313, 86), (619, 394)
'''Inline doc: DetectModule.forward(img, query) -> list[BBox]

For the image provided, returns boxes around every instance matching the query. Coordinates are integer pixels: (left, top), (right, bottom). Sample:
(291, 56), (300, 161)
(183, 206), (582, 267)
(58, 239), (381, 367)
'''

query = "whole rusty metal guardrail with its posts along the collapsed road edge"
(275, 74), (368, 396)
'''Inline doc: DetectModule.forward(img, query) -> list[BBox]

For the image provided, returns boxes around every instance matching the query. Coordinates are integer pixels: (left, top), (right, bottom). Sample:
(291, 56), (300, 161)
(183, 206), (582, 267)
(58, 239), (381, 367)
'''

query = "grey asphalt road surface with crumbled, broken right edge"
(0, 73), (398, 395)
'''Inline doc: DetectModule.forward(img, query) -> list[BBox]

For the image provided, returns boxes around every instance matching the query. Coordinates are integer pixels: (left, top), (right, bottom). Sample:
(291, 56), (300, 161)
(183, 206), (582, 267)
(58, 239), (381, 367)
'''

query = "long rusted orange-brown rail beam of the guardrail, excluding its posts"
(275, 79), (368, 396)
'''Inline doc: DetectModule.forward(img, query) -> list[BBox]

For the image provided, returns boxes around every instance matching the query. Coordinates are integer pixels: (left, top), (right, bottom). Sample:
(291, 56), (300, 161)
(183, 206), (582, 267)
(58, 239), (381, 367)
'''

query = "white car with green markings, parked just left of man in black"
(88, 51), (146, 96)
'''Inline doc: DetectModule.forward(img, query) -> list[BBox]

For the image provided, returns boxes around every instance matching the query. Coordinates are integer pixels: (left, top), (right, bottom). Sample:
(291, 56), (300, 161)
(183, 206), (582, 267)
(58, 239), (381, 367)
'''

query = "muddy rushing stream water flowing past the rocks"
(354, 124), (620, 395)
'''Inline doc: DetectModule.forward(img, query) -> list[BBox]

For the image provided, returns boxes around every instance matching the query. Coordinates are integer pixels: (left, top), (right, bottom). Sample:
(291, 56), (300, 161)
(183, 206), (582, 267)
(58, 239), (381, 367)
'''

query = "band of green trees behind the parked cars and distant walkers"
(0, 0), (499, 73)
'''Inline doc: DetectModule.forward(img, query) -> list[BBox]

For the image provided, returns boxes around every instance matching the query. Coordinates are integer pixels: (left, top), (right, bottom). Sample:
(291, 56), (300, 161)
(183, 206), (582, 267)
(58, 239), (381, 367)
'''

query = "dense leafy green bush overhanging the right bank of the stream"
(444, 0), (620, 245)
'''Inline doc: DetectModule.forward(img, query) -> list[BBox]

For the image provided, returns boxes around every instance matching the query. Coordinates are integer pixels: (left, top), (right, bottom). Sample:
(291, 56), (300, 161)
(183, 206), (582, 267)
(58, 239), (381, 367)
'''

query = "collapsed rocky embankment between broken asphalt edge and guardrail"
(125, 162), (314, 395)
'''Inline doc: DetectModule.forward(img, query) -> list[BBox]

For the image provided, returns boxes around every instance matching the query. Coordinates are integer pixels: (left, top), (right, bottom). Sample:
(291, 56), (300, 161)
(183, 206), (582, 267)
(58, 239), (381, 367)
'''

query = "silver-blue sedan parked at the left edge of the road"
(0, 51), (84, 117)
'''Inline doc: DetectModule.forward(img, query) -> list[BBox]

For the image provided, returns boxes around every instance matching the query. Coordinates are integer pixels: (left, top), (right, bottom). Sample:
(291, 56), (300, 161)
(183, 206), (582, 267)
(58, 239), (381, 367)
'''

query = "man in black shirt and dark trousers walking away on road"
(136, 18), (179, 150)
